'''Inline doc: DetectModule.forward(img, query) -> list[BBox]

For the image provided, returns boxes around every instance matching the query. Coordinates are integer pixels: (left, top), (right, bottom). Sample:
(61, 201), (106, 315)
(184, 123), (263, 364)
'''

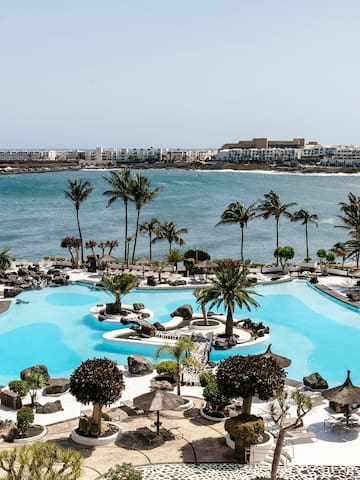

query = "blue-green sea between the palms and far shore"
(0, 170), (360, 263)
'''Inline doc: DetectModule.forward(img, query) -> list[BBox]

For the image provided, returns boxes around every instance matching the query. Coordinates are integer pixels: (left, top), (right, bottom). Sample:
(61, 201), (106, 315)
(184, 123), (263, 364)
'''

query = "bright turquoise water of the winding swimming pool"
(0, 281), (360, 385)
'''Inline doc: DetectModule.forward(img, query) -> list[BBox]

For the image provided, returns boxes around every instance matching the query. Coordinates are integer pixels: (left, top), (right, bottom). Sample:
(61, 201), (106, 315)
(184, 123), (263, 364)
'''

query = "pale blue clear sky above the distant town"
(0, 0), (360, 149)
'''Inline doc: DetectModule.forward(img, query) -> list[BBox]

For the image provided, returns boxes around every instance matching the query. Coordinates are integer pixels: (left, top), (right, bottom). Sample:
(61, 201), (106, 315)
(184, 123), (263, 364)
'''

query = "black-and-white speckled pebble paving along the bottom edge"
(140, 463), (360, 480)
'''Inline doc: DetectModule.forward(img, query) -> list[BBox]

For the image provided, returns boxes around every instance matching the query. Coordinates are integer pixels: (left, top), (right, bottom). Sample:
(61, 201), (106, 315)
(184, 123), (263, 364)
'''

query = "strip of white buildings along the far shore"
(0, 138), (360, 174)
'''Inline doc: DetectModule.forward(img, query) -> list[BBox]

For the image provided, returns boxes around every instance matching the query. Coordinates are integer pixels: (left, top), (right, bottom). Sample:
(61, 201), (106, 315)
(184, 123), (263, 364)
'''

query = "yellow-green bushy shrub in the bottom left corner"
(0, 442), (82, 480)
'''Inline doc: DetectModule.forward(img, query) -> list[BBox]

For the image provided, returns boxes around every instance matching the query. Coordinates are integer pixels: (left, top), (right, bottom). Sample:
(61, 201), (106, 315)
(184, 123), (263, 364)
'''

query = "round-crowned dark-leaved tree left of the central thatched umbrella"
(70, 358), (125, 437)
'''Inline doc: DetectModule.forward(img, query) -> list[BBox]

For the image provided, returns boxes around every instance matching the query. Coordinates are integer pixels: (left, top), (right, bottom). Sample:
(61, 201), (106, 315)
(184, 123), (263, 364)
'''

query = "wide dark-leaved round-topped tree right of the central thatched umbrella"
(216, 355), (285, 415)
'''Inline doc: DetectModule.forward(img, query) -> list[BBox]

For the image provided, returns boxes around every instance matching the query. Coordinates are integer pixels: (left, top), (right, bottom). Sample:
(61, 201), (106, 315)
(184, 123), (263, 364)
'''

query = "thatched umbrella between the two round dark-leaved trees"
(133, 389), (184, 435)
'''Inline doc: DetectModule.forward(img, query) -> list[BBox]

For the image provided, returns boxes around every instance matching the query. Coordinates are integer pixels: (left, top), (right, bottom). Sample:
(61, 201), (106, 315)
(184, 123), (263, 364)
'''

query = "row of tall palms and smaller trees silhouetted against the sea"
(57, 167), (360, 266)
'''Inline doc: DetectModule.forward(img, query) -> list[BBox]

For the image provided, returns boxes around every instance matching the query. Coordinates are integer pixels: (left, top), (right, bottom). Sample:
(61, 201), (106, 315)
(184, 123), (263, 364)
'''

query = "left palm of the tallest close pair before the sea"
(103, 167), (132, 262)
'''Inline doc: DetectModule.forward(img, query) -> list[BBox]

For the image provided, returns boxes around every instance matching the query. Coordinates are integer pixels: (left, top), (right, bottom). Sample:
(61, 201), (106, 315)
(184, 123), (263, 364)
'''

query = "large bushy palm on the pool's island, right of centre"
(196, 260), (260, 337)
